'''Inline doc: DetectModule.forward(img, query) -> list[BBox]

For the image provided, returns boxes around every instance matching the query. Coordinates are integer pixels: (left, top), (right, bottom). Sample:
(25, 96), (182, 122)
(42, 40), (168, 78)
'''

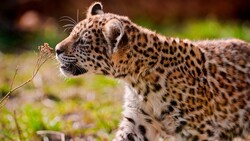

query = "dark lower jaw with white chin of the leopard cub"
(60, 63), (87, 76)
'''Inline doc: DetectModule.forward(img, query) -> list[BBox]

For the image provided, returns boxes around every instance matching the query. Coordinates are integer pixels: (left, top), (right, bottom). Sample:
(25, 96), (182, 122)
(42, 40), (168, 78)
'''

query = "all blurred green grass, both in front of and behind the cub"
(0, 20), (250, 141)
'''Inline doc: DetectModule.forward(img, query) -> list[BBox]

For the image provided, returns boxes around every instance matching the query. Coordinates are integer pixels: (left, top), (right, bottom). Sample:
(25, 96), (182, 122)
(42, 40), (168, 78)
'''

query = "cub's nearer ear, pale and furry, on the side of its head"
(102, 19), (127, 54)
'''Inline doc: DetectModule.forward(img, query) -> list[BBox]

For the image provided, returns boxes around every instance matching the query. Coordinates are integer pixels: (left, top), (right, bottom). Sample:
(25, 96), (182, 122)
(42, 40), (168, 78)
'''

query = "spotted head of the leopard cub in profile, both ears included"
(55, 2), (130, 76)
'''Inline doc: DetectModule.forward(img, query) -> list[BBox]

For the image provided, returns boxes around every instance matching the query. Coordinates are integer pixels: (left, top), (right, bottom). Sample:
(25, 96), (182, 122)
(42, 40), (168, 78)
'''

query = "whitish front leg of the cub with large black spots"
(113, 111), (157, 141)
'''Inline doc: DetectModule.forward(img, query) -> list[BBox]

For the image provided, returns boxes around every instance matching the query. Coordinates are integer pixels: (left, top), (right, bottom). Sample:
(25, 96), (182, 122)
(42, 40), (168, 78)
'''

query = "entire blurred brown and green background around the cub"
(0, 0), (250, 141)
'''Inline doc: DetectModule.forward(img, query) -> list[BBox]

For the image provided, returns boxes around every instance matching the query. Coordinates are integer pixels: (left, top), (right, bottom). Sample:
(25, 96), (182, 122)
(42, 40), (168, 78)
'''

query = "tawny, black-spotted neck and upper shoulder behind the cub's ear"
(113, 25), (205, 87)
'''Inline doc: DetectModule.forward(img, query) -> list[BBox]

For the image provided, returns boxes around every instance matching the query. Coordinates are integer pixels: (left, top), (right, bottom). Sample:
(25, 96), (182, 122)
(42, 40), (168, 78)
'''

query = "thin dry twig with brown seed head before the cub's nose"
(0, 43), (54, 108)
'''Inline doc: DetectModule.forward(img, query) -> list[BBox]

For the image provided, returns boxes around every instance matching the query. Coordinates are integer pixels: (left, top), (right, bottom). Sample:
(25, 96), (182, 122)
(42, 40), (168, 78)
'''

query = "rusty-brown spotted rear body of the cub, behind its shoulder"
(196, 39), (250, 136)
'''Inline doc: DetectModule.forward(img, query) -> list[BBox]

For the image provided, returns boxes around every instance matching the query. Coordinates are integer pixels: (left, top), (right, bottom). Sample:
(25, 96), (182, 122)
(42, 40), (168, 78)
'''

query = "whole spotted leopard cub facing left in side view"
(56, 3), (250, 141)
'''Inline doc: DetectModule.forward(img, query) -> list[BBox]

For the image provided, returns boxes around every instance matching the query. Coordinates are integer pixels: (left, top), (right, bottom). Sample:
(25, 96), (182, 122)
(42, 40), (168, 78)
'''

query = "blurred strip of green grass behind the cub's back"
(135, 19), (250, 41)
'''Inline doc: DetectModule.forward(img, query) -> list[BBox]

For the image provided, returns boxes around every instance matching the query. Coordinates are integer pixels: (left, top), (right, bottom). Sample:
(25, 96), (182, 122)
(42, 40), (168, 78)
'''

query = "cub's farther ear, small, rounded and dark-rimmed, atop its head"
(87, 2), (104, 18)
